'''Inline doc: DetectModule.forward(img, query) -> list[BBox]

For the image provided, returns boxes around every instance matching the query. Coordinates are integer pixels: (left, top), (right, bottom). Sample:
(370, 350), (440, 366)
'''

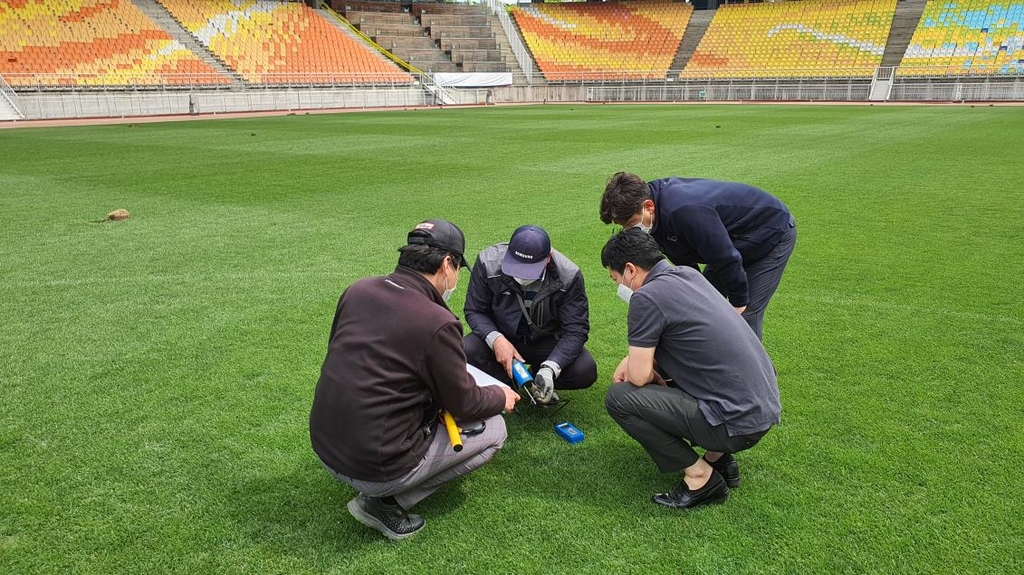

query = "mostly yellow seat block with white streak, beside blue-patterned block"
(680, 0), (896, 78)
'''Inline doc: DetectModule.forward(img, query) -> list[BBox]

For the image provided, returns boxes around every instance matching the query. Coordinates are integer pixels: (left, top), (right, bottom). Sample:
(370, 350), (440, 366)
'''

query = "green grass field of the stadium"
(0, 105), (1024, 575)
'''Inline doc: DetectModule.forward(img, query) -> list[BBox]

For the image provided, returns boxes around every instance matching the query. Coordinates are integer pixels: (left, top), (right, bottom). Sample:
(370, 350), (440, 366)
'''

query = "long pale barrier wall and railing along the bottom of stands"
(11, 71), (1024, 120)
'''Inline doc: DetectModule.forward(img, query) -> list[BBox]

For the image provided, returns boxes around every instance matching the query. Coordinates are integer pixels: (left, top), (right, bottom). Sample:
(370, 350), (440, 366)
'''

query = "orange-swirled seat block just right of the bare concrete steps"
(511, 1), (693, 81)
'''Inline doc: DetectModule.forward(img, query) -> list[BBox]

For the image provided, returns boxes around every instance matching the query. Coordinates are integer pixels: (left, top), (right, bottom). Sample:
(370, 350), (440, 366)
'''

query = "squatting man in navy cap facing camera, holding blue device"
(463, 225), (597, 403)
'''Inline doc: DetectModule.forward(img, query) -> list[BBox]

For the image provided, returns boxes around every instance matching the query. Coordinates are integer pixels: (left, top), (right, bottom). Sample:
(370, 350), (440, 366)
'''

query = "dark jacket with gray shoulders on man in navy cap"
(463, 242), (590, 367)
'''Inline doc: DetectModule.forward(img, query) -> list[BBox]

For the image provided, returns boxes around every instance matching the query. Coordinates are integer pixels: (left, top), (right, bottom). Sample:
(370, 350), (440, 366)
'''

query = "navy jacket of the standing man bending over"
(647, 178), (793, 307)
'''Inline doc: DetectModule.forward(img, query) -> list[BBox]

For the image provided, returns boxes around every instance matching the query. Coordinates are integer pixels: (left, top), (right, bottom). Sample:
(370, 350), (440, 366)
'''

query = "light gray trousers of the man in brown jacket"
(324, 415), (508, 511)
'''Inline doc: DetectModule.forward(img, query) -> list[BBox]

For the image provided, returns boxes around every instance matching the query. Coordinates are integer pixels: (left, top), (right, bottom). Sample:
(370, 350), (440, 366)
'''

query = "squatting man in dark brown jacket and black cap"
(309, 220), (519, 539)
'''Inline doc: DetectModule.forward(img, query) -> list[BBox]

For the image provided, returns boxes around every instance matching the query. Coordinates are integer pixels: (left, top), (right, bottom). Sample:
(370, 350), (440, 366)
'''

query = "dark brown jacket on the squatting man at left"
(309, 266), (505, 481)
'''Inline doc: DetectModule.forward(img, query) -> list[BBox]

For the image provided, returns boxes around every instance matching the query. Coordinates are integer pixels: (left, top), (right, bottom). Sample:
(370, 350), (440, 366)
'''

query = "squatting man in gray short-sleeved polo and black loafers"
(601, 229), (780, 508)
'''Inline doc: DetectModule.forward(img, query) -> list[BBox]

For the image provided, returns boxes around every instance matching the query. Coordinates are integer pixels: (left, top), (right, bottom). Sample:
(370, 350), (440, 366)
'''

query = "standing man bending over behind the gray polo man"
(601, 172), (797, 340)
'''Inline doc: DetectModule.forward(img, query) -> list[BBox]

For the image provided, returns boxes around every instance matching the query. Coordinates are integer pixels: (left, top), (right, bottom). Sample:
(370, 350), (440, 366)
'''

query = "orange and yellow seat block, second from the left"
(158, 0), (413, 85)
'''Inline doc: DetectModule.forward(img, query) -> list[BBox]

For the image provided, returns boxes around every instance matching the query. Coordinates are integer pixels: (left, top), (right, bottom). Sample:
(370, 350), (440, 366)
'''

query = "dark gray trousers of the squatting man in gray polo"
(604, 384), (768, 473)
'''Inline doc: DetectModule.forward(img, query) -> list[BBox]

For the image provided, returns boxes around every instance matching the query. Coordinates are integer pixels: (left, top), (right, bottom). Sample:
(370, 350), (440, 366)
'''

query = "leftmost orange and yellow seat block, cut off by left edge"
(0, 0), (230, 88)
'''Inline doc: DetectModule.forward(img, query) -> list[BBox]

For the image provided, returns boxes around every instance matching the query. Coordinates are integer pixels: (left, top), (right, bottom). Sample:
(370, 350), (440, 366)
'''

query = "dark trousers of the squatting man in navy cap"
(462, 334), (597, 390)
